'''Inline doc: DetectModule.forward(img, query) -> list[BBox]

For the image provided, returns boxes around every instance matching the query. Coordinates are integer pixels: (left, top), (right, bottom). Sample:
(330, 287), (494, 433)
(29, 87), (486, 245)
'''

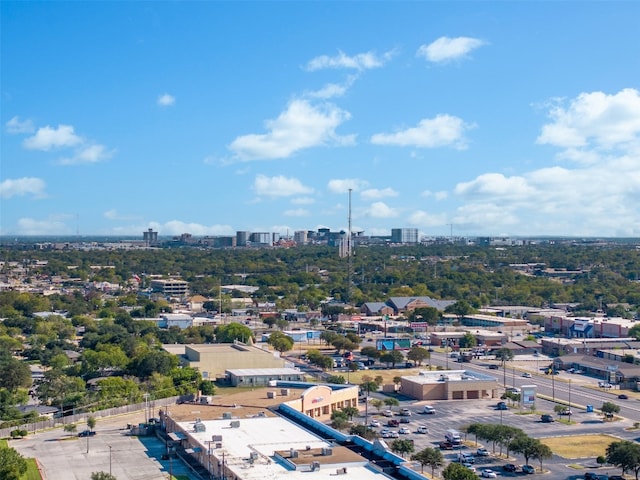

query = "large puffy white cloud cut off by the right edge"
(537, 88), (640, 158)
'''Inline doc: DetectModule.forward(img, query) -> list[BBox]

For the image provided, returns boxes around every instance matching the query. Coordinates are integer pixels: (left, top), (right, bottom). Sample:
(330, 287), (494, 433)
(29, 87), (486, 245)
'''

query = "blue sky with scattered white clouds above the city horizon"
(0, 1), (640, 237)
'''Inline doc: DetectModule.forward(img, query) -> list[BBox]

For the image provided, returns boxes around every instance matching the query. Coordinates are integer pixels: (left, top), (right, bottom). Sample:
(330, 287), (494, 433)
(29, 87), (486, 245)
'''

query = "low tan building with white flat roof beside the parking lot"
(400, 370), (499, 400)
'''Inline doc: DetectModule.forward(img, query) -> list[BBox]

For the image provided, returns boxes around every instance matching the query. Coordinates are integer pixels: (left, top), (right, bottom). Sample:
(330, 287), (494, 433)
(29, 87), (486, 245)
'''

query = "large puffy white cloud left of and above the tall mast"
(229, 100), (355, 161)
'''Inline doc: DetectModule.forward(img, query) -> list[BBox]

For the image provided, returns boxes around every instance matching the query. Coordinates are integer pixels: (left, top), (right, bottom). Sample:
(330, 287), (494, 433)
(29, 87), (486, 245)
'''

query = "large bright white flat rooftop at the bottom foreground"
(179, 417), (389, 480)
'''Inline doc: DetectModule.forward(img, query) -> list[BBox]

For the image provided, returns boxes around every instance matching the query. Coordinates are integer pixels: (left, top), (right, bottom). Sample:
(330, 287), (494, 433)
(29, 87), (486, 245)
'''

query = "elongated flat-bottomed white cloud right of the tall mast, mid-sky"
(371, 115), (474, 149)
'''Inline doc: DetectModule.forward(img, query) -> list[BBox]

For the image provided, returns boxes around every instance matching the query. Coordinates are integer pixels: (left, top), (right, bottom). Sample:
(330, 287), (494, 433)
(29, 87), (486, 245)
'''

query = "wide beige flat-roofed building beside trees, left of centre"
(163, 343), (291, 380)
